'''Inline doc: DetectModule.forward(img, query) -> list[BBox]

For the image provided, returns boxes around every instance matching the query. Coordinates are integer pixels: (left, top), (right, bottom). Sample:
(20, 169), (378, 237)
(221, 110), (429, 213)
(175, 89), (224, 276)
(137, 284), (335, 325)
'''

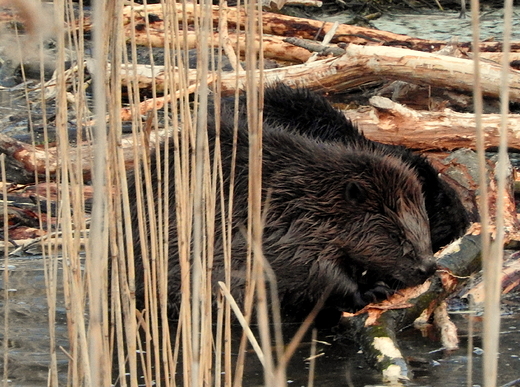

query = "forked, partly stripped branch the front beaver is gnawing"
(341, 235), (480, 381)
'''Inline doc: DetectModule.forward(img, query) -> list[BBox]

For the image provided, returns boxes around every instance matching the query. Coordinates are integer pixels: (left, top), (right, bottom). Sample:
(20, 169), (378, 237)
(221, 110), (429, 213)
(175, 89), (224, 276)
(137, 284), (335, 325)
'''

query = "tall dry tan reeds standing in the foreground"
(1, 0), (511, 387)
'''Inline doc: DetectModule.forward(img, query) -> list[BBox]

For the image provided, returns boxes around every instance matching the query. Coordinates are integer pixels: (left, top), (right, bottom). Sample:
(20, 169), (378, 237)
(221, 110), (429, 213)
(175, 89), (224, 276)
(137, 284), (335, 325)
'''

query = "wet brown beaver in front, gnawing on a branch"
(128, 91), (436, 323)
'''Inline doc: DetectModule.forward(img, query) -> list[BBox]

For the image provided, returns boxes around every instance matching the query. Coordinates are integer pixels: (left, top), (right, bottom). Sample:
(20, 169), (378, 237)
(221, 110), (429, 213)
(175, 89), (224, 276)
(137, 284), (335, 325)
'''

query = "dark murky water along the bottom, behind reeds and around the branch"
(0, 257), (520, 387)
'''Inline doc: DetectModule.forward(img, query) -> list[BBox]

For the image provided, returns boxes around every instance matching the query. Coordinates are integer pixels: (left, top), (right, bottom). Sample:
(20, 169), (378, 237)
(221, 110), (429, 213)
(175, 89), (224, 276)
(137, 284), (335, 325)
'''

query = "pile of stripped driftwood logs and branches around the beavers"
(0, 0), (520, 379)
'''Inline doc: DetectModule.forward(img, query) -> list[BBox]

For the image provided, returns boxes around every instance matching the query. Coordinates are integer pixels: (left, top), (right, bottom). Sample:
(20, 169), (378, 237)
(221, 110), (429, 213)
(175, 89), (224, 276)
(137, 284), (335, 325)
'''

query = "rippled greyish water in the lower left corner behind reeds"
(0, 257), (68, 387)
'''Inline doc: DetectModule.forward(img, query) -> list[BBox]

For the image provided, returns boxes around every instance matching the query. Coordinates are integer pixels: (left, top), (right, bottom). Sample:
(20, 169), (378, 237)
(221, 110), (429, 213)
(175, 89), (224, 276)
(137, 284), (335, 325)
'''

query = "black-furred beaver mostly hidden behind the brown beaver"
(254, 83), (470, 252)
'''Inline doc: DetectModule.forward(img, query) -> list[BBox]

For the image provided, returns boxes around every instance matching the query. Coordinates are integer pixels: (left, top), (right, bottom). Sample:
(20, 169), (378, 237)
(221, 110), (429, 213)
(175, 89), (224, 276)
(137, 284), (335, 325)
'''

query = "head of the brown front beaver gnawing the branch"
(339, 156), (436, 286)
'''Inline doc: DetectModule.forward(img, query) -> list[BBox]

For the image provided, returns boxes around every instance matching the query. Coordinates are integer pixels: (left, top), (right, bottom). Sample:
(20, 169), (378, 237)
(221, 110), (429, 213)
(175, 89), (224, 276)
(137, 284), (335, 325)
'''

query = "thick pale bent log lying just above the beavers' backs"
(124, 44), (520, 119)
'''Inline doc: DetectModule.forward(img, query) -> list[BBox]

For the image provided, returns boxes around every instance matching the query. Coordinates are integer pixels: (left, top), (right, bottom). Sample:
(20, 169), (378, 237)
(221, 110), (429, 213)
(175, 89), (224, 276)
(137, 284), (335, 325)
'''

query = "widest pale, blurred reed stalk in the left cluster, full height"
(85, 1), (117, 386)
